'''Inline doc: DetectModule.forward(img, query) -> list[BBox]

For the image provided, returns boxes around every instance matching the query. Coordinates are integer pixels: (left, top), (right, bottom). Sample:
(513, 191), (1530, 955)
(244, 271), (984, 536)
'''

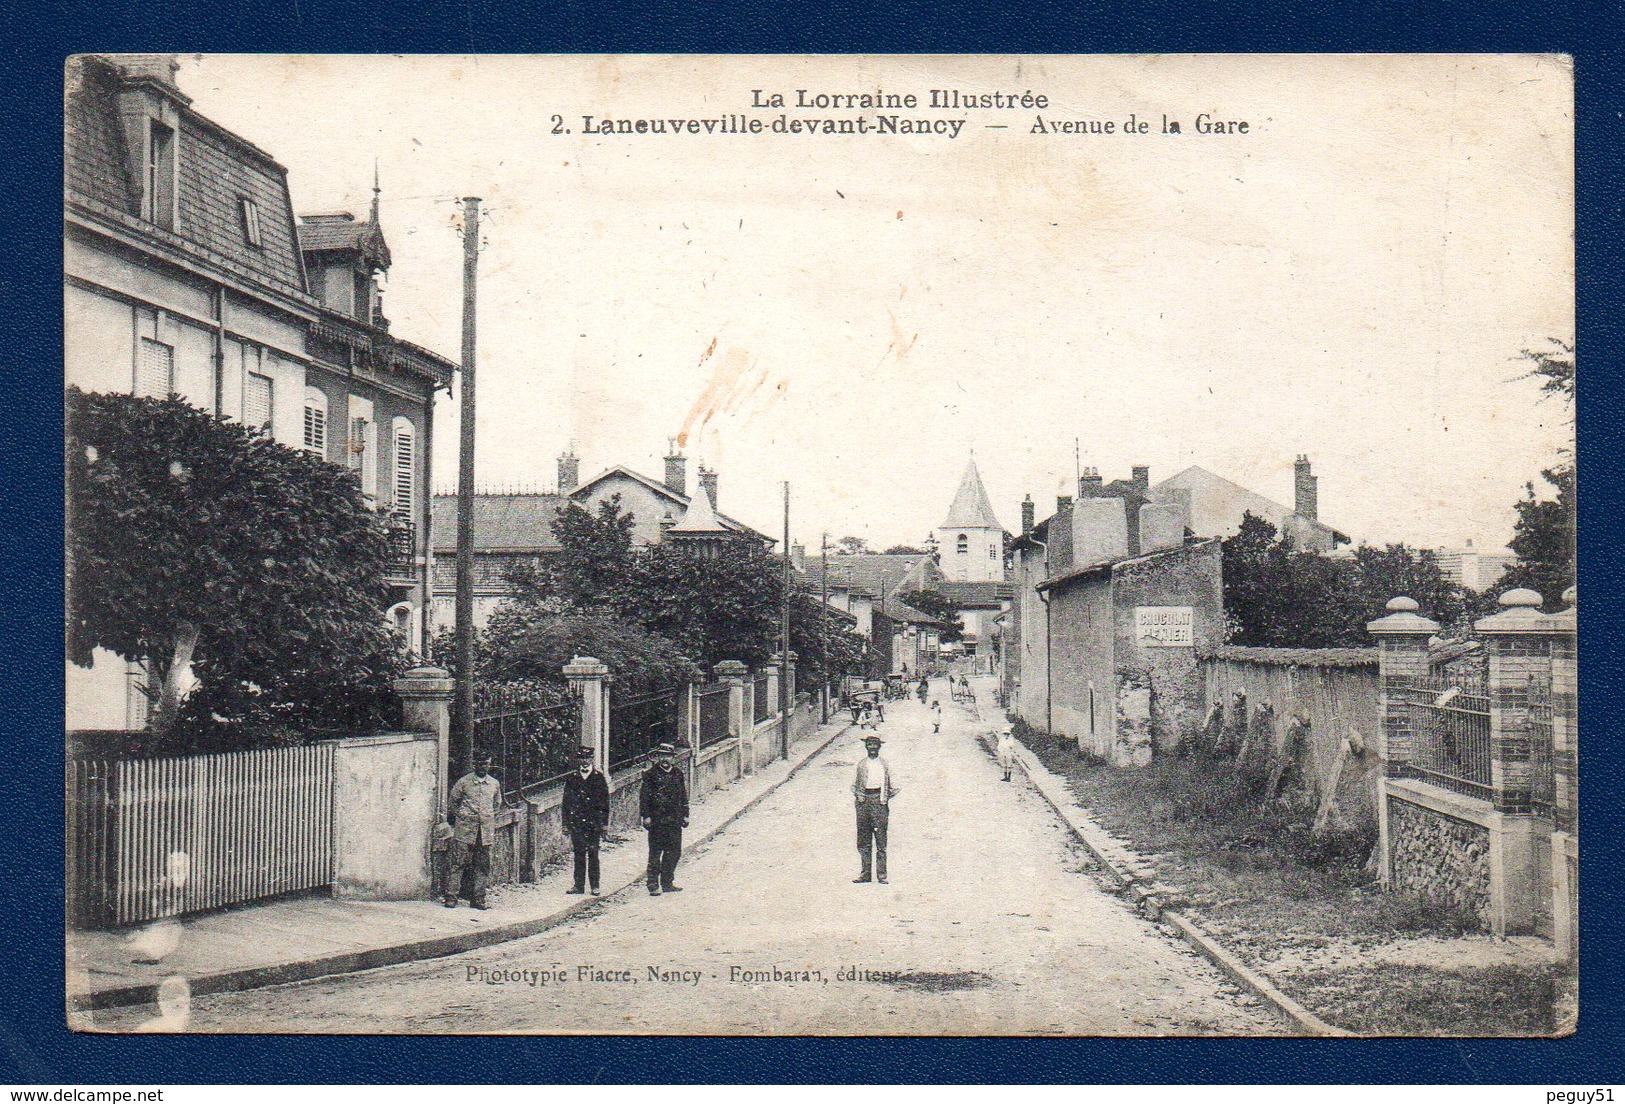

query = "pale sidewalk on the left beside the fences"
(67, 717), (848, 1008)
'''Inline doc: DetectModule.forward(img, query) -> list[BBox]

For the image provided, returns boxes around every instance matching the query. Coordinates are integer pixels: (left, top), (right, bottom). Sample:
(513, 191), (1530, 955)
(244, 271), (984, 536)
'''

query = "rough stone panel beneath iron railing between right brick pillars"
(1388, 798), (1490, 927)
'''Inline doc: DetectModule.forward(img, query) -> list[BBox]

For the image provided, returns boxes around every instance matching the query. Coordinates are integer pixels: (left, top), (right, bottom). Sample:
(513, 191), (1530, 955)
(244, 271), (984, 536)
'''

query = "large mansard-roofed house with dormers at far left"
(63, 55), (457, 728)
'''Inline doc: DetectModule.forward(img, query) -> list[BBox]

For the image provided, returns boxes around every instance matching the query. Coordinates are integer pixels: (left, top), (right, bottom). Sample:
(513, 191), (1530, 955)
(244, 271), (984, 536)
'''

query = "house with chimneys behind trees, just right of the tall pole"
(432, 442), (774, 629)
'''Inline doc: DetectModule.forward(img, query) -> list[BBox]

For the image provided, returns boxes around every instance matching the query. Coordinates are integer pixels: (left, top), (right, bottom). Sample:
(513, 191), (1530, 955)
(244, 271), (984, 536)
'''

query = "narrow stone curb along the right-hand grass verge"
(978, 733), (1357, 1037)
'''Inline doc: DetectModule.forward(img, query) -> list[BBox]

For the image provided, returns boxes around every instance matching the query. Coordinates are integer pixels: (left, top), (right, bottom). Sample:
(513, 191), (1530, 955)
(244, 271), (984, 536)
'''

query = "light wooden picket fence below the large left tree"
(67, 745), (333, 925)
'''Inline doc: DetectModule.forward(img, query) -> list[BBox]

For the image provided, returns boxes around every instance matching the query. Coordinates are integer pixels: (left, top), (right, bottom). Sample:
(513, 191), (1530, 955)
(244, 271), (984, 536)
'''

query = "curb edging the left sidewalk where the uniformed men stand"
(68, 722), (852, 1031)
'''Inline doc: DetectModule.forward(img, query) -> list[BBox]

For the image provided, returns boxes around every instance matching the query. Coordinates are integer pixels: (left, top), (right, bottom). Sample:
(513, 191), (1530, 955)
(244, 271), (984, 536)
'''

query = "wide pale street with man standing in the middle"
(102, 681), (1281, 1034)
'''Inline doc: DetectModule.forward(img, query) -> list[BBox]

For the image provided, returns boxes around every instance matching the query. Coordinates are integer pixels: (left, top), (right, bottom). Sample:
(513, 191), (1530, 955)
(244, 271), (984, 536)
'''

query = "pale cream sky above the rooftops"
(177, 55), (1575, 546)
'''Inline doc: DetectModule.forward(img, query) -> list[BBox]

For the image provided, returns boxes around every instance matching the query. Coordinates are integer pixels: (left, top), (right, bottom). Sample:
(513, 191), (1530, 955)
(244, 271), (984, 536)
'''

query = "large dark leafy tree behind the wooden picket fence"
(67, 387), (400, 740)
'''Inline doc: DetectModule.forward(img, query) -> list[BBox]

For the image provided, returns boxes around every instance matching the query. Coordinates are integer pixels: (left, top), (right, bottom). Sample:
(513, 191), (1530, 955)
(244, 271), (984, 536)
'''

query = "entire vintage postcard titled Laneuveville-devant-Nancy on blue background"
(63, 54), (1580, 1037)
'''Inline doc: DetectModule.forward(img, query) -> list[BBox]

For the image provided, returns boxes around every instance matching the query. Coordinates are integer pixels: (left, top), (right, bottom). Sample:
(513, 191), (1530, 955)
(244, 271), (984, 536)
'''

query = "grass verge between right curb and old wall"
(1024, 733), (1563, 1037)
